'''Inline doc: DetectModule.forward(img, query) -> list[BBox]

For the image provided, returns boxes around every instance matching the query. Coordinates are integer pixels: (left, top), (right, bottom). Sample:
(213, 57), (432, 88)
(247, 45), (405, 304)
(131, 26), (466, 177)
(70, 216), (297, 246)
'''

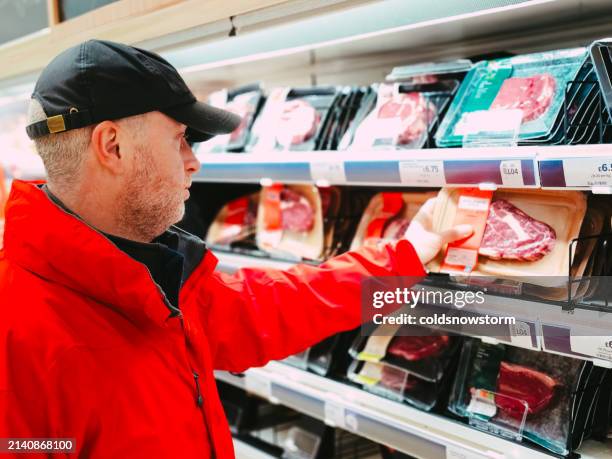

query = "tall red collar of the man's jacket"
(4, 180), (214, 324)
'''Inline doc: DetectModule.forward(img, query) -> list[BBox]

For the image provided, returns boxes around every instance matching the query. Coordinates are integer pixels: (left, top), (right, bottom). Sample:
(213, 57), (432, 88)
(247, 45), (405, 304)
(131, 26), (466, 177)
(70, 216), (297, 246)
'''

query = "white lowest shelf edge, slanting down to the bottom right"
(215, 362), (612, 459)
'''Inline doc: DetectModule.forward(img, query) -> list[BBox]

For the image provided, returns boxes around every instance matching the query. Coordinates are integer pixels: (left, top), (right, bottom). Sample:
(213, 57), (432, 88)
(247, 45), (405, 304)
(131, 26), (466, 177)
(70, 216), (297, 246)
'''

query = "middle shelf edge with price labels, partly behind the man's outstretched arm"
(215, 252), (612, 368)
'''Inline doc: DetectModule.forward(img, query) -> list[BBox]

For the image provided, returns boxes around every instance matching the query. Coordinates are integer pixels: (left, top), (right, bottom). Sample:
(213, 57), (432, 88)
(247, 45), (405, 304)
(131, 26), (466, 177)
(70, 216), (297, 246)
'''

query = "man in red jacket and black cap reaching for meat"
(0, 40), (471, 458)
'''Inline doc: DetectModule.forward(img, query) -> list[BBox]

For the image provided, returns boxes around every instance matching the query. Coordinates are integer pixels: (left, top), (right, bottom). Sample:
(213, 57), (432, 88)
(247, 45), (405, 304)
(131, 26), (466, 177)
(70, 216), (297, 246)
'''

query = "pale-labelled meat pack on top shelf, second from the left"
(247, 86), (339, 152)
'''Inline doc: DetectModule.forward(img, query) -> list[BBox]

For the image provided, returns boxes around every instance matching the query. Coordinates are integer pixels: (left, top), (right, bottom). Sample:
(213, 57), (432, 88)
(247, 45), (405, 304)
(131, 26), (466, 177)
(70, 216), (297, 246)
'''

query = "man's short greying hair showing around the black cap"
(27, 99), (146, 190)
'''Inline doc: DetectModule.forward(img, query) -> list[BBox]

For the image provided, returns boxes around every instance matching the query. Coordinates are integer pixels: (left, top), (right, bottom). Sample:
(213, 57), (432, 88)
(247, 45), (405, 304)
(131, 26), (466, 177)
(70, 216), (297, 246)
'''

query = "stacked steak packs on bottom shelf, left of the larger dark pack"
(347, 325), (461, 411)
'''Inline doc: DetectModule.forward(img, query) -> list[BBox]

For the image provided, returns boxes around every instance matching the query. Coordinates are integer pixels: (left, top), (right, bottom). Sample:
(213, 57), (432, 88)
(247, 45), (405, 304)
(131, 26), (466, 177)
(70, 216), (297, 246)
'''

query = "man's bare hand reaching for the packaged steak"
(404, 198), (474, 264)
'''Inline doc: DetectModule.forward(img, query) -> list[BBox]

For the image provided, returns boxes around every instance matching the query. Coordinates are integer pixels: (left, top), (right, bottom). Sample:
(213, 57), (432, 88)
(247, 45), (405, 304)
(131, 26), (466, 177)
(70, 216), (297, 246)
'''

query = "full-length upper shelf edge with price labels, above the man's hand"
(194, 145), (612, 193)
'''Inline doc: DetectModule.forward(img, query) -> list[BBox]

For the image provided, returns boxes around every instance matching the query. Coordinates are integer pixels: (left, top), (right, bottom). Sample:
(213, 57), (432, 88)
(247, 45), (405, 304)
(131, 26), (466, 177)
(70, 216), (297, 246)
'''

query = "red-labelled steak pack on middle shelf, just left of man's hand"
(351, 192), (436, 249)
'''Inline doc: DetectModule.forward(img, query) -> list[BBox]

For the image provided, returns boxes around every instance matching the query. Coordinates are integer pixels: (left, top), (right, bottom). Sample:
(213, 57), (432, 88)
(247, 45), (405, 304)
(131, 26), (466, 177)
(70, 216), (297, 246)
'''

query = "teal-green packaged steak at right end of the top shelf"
(436, 48), (609, 147)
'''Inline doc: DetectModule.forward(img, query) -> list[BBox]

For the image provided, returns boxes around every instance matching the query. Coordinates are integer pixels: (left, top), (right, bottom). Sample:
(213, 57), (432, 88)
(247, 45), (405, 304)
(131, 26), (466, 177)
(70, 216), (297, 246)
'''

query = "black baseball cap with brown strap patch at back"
(26, 40), (240, 142)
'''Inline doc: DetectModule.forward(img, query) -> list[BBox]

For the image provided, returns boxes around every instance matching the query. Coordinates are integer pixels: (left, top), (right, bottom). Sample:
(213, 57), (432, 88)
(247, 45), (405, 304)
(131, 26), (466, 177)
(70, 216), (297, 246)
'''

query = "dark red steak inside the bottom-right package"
(495, 362), (559, 419)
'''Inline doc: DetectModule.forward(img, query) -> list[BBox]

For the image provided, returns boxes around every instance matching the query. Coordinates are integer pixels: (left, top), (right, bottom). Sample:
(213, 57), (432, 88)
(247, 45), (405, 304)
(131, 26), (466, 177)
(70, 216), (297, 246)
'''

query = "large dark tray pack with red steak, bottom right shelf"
(449, 339), (609, 455)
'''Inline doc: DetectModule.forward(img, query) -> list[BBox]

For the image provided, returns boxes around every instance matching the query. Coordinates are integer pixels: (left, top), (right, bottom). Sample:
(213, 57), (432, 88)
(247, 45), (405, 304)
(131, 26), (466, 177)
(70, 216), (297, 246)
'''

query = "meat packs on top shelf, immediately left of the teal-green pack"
(338, 61), (471, 151)
